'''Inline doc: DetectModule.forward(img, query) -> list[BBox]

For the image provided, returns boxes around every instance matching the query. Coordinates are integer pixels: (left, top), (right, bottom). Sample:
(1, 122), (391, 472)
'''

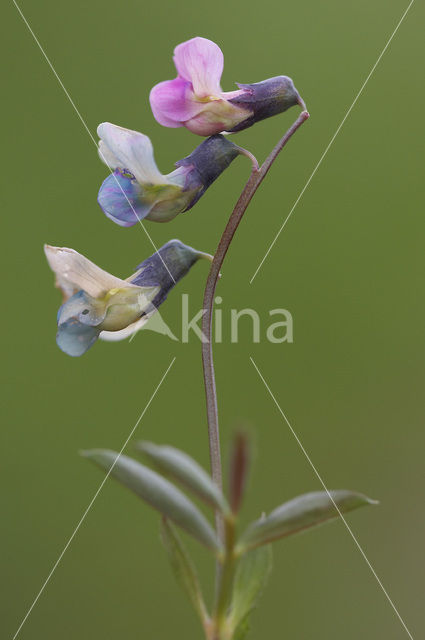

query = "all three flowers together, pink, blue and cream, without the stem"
(45, 37), (304, 356)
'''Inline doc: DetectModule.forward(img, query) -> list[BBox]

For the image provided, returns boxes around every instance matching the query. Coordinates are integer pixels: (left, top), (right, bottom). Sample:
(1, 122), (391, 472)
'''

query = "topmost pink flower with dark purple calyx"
(150, 37), (305, 136)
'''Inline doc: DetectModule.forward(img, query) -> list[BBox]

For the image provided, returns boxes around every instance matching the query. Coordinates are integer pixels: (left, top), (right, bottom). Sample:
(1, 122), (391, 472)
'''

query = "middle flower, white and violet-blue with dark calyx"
(97, 122), (241, 227)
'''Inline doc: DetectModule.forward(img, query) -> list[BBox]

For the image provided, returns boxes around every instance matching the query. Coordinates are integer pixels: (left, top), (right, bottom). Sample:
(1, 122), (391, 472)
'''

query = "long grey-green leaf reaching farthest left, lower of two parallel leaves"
(82, 449), (221, 552)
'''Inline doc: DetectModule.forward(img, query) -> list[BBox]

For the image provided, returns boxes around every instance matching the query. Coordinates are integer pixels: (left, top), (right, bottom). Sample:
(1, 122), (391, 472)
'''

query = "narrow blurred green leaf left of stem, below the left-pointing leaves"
(161, 518), (208, 626)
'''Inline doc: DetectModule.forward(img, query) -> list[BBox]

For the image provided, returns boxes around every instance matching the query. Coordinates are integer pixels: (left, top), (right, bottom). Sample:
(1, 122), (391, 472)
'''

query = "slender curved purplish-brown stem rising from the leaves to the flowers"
(202, 111), (310, 539)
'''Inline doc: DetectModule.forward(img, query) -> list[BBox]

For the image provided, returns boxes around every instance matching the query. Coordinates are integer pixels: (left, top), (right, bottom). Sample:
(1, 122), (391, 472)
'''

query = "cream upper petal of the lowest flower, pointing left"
(44, 244), (134, 298)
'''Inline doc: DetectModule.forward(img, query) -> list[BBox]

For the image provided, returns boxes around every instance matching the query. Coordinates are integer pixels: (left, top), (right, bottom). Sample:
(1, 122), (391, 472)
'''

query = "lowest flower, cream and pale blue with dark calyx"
(44, 240), (212, 356)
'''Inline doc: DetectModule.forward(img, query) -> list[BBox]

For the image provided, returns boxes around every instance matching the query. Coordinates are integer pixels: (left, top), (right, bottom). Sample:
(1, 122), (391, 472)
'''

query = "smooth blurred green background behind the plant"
(0, 0), (425, 640)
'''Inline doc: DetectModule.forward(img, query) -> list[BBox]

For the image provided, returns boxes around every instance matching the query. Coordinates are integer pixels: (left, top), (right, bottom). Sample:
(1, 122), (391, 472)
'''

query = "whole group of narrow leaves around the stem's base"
(83, 437), (376, 640)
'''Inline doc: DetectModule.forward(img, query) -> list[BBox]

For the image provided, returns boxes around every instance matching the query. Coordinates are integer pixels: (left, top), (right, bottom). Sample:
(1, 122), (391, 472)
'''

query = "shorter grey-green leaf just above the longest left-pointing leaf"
(136, 442), (230, 513)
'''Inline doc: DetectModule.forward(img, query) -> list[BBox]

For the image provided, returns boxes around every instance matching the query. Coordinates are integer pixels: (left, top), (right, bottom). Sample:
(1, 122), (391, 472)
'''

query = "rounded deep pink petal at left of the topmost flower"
(149, 78), (205, 127)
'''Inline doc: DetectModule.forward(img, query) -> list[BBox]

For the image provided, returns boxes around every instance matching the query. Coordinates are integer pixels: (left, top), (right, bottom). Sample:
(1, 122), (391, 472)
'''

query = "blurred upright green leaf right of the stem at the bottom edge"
(229, 544), (272, 640)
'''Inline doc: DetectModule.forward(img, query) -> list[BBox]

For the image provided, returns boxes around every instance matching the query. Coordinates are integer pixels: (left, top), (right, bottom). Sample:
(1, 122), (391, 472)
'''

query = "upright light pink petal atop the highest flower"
(174, 38), (224, 98)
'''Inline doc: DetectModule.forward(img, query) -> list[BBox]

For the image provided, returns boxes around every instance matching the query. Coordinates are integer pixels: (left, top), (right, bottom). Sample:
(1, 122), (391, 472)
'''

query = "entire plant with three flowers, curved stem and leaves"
(40, 38), (375, 640)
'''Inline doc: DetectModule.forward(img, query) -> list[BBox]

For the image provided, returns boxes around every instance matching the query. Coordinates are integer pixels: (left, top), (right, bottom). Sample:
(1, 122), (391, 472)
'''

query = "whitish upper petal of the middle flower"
(97, 122), (164, 184)
